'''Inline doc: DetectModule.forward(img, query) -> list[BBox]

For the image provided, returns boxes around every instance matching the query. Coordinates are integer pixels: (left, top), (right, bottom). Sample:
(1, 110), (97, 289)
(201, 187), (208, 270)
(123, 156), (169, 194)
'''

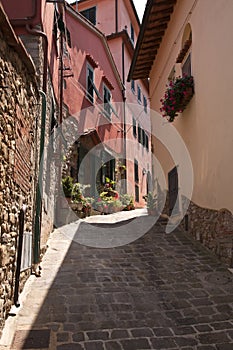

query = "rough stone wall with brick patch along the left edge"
(0, 28), (39, 331)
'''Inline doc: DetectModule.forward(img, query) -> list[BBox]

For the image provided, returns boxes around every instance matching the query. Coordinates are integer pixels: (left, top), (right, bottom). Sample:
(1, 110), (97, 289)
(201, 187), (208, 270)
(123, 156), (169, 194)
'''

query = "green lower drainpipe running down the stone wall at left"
(33, 90), (46, 264)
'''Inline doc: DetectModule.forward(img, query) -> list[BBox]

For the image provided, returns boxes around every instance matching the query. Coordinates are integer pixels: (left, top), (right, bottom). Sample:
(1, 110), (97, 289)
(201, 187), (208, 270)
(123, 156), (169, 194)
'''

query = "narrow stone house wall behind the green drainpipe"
(21, 31), (57, 257)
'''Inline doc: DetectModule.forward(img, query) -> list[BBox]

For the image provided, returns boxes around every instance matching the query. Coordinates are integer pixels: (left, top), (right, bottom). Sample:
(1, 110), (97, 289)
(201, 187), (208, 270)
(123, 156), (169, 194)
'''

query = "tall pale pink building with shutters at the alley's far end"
(72, 0), (151, 206)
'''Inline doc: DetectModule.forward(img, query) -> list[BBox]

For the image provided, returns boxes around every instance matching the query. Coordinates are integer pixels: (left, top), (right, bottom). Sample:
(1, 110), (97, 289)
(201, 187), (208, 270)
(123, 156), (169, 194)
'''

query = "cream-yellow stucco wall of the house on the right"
(150, 0), (233, 211)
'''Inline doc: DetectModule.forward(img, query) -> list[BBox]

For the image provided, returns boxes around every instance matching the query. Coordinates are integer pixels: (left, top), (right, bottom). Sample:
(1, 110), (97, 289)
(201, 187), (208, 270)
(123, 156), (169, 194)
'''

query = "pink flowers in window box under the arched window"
(160, 76), (194, 122)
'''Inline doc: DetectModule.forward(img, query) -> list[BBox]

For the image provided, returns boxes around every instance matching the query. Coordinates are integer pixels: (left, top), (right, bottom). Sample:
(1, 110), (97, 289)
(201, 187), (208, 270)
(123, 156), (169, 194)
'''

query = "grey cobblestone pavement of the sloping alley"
(2, 217), (233, 350)
